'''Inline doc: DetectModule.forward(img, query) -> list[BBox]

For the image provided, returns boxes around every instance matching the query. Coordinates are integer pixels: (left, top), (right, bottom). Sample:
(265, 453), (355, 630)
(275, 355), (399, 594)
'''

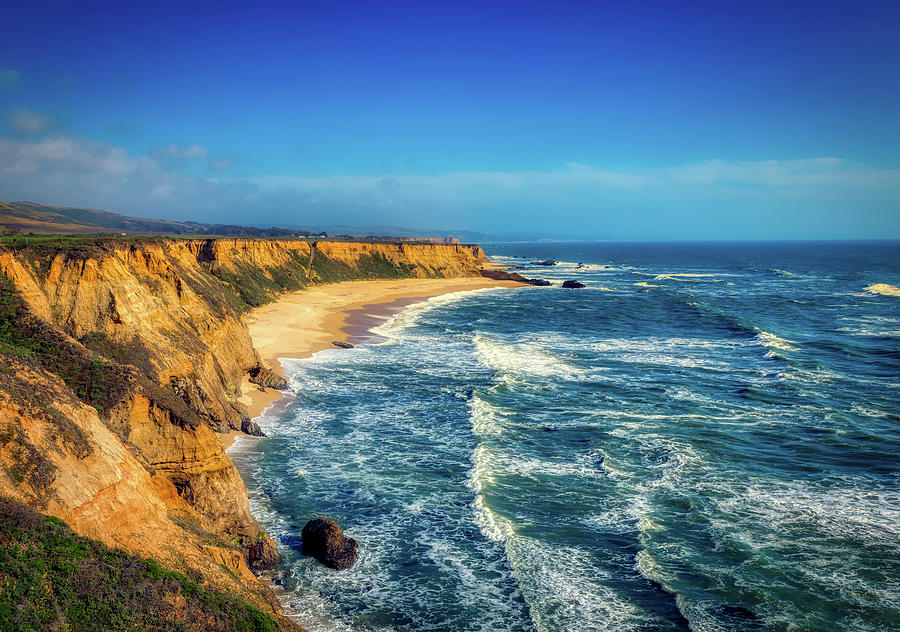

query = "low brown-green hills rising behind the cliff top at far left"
(0, 202), (205, 235)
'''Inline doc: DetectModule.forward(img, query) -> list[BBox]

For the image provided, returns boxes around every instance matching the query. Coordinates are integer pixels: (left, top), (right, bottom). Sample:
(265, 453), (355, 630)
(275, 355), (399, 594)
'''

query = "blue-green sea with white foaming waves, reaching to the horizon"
(229, 243), (900, 631)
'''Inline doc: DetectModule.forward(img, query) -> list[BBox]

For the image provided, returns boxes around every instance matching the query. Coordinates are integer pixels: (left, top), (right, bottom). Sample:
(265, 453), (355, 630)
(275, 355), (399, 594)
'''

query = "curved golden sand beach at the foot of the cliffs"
(219, 278), (522, 448)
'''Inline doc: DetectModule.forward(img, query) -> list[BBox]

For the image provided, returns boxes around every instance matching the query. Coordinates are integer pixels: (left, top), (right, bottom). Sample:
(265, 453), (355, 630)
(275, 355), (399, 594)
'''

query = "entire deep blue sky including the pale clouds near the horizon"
(0, 1), (900, 239)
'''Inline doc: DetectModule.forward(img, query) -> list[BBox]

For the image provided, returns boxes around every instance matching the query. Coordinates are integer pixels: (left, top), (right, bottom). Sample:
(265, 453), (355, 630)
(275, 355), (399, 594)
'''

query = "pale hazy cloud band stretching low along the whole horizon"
(0, 135), (900, 238)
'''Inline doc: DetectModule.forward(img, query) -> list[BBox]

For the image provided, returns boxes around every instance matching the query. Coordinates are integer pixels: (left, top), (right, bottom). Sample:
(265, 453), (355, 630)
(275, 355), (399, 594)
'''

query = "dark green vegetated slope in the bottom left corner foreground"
(0, 497), (286, 632)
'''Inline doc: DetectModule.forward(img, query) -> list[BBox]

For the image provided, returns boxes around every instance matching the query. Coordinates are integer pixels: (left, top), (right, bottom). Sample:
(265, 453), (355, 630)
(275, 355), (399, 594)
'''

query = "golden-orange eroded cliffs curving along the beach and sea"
(0, 239), (487, 611)
